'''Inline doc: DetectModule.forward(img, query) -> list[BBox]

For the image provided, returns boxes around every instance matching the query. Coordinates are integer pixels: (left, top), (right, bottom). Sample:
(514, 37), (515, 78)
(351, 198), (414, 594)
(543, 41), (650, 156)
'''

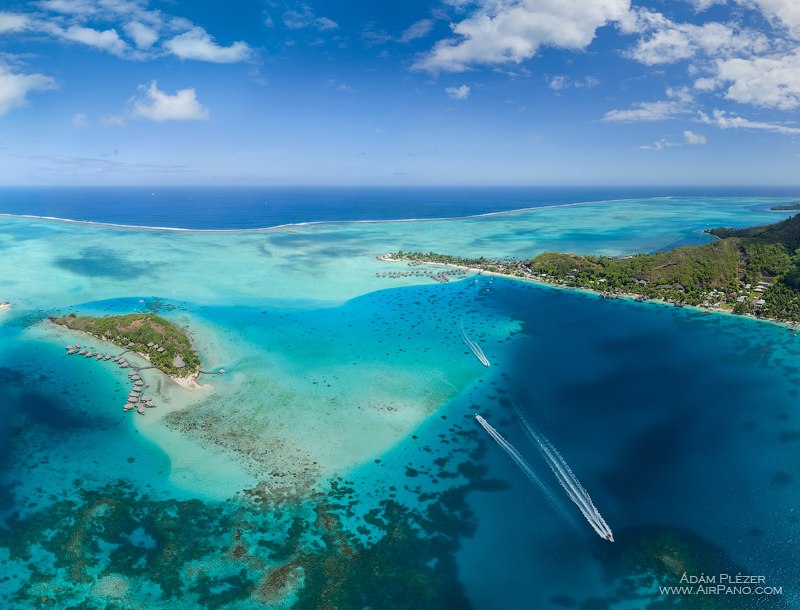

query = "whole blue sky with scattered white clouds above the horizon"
(0, 0), (800, 185)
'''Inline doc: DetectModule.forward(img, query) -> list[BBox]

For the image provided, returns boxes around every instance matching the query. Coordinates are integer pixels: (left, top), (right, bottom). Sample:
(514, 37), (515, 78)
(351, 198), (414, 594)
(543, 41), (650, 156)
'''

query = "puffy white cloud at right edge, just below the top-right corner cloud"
(717, 49), (800, 110)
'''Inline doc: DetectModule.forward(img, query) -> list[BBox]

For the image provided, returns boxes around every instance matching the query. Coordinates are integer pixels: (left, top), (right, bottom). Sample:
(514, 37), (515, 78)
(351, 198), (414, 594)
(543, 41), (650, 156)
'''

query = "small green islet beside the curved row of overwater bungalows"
(50, 313), (200, 377)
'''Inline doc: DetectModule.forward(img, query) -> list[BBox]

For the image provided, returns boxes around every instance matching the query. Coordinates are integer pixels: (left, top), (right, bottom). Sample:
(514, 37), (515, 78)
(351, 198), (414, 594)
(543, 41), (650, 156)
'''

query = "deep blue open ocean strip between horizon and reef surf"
(0, 186), (800, 229)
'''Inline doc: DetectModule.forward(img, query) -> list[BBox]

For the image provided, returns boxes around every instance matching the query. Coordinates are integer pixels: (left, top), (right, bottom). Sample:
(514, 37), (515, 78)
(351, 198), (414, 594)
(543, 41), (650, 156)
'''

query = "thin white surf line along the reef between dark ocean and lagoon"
(0, 195), (796, 234)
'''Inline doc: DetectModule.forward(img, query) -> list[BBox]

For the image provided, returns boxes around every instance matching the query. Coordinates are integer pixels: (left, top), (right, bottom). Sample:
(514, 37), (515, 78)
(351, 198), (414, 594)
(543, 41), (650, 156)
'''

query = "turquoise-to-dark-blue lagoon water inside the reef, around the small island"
(0, 198), (800, 609)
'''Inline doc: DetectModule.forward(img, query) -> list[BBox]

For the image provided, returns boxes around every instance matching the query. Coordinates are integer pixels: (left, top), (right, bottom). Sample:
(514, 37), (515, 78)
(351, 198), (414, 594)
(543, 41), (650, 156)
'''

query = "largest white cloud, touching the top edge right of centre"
(415, 0), (630, 72)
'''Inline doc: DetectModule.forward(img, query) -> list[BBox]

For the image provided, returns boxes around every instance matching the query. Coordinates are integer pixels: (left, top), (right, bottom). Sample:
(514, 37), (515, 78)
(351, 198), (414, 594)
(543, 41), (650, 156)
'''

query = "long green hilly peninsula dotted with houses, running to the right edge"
(383, 210), (800, 322)
